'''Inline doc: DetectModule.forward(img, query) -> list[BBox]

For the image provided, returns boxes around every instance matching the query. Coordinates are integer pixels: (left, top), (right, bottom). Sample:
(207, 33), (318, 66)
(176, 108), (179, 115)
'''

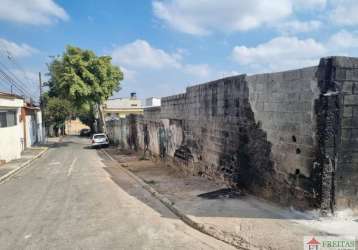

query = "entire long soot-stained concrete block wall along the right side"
(106, 57), (358, 213)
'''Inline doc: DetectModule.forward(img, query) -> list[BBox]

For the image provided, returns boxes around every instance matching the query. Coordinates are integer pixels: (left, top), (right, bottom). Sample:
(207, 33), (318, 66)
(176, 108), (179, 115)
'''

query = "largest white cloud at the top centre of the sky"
(153, 0), (293, 35)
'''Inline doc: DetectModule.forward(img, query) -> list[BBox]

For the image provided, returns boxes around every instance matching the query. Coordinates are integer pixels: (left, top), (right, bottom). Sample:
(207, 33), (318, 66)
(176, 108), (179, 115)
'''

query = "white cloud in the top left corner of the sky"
(0, 0), (69, 25)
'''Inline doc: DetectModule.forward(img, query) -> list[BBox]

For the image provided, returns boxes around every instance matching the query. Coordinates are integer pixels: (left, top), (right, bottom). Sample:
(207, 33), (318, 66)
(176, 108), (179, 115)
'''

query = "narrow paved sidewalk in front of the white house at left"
(0, 147), (48, 183)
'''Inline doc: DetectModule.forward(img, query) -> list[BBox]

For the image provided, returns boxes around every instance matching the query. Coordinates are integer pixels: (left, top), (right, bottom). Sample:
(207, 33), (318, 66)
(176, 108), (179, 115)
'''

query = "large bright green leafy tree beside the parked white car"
(48, 46), (123, 132)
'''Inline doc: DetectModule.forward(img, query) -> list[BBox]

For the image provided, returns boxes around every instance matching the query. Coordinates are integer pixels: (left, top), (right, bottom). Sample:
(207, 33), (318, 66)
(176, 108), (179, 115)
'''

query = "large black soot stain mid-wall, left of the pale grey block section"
(219, 79), (274, 196)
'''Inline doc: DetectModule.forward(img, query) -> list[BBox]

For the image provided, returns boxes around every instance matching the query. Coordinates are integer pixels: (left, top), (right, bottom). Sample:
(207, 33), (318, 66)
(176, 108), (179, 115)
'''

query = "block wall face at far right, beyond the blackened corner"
(332, 58), (358, 213)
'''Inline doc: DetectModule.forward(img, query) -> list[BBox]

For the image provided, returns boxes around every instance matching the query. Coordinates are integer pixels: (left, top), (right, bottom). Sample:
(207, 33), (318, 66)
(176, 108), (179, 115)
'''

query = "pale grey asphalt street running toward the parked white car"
(0, 137), (233, 250)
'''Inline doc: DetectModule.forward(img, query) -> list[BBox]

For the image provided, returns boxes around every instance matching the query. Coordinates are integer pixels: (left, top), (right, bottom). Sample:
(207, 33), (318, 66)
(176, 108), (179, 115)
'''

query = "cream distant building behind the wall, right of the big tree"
(103, 93), (143, 120)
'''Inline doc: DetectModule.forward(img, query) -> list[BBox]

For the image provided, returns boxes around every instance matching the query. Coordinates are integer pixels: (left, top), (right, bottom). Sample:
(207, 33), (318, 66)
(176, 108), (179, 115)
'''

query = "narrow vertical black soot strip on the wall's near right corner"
(314, 58), (340, 215)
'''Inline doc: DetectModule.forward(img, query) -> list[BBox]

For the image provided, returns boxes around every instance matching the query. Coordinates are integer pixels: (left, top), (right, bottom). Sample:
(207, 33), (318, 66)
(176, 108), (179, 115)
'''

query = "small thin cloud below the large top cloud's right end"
(277, 20), (322, 34)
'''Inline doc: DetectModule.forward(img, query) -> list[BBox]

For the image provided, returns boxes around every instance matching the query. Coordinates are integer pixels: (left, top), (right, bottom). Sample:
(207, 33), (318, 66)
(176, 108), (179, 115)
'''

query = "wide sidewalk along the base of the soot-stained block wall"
(106, 149), (358, 250)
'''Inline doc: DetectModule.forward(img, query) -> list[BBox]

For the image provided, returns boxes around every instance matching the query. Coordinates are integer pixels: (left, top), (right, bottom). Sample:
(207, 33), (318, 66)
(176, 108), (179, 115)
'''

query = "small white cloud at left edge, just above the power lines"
(0, 38), (37, 57)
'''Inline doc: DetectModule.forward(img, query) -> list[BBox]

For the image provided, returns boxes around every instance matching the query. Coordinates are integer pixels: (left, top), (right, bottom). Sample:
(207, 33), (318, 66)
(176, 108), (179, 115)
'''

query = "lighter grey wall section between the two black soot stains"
(247, 67), (320, 205)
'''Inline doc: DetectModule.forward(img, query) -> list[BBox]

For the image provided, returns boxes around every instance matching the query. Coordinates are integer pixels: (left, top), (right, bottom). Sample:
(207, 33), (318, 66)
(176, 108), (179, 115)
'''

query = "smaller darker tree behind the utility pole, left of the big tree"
(44, 97), (71, 136)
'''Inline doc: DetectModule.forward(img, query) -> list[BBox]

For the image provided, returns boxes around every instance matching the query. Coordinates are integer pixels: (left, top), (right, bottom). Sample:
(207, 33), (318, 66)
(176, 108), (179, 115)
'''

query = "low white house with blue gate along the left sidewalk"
(0, 92), (44, 163)
